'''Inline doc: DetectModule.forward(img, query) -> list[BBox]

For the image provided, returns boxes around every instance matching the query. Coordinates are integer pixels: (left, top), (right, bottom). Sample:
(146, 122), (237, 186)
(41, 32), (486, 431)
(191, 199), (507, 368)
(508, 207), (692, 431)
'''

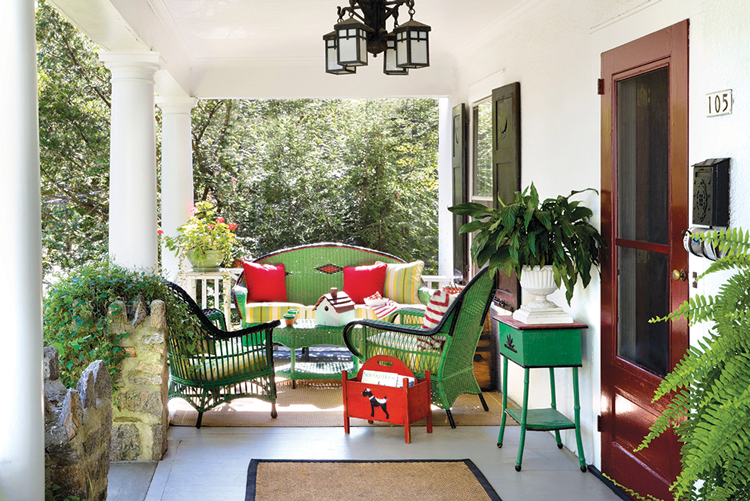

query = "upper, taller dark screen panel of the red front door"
(617, 68), (669, 244)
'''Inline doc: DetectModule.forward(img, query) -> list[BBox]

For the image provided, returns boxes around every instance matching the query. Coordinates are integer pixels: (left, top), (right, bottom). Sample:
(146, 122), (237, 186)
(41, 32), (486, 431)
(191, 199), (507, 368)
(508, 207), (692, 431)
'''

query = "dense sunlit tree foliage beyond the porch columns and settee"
(37, 0), (438, 277)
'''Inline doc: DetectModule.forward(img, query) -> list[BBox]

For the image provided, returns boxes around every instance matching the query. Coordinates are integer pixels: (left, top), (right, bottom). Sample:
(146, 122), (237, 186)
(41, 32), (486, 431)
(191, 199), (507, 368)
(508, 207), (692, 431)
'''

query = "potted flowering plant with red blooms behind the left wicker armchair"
(159, 201), (237, 271)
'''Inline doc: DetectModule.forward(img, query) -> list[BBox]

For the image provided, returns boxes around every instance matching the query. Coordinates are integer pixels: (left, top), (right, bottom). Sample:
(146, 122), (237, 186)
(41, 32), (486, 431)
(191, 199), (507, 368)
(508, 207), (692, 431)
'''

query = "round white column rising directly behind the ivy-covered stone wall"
(99, 51), (160, 271)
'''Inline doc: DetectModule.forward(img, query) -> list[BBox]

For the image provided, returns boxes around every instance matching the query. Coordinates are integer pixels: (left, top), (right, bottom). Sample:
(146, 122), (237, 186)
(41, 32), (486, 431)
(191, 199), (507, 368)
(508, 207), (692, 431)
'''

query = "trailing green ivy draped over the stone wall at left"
(44, 261), (196, 396)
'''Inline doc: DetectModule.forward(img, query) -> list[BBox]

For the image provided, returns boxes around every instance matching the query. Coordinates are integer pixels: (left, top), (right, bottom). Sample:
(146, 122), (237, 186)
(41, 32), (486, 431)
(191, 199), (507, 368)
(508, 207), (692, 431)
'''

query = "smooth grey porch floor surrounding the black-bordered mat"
(108, 426), (621, 501)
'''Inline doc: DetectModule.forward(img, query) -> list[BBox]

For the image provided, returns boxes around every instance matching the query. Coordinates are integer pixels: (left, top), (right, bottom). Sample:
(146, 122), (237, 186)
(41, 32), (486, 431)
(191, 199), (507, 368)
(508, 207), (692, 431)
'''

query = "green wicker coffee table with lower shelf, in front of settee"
(273, 319), (359, 388)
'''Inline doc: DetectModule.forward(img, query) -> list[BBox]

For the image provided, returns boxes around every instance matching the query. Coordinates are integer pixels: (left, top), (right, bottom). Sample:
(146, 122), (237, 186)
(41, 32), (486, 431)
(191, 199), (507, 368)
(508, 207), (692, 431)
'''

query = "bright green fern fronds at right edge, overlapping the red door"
(637, 229), (750, 501)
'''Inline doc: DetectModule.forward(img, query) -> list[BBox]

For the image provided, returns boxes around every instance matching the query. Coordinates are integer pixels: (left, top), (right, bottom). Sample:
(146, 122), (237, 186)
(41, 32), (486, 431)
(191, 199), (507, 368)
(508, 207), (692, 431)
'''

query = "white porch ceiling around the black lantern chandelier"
(51, 0), (528, 98)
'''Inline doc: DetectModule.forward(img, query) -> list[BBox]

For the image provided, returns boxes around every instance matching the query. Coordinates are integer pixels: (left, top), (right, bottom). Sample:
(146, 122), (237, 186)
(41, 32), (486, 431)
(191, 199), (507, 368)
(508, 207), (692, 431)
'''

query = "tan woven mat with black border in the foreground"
(245, 459), (502, 501)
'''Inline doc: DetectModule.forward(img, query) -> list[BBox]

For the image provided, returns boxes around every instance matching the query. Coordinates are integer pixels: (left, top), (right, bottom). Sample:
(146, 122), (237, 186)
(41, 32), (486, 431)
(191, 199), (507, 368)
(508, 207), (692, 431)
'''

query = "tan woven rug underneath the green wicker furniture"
(169, 381), (515, 428)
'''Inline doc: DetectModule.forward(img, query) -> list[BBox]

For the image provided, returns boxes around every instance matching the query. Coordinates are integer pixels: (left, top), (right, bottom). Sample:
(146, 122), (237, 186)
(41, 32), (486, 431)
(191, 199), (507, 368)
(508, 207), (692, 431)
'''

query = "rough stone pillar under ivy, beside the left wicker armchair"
(110, 300), (169, 461)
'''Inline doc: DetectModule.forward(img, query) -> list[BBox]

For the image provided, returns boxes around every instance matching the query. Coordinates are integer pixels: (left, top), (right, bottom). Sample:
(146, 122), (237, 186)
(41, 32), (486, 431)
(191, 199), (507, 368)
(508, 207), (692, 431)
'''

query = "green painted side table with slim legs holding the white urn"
(496, 316), (588, 472)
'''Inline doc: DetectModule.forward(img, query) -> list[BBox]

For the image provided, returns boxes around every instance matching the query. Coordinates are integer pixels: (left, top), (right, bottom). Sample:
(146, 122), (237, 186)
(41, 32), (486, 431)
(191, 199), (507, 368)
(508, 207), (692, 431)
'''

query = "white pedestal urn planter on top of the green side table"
(513, 265), (573, 324)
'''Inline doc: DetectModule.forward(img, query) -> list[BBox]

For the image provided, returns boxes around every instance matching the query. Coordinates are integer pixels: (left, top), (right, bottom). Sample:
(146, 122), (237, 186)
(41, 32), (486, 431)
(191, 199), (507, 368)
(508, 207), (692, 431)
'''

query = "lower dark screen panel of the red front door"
(617, 247), (669, 376)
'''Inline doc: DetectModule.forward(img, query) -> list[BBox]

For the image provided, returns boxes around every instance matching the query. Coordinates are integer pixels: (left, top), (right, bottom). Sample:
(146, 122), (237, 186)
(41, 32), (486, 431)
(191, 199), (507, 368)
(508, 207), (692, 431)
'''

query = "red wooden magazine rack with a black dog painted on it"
(342, 355), (432, 444)
